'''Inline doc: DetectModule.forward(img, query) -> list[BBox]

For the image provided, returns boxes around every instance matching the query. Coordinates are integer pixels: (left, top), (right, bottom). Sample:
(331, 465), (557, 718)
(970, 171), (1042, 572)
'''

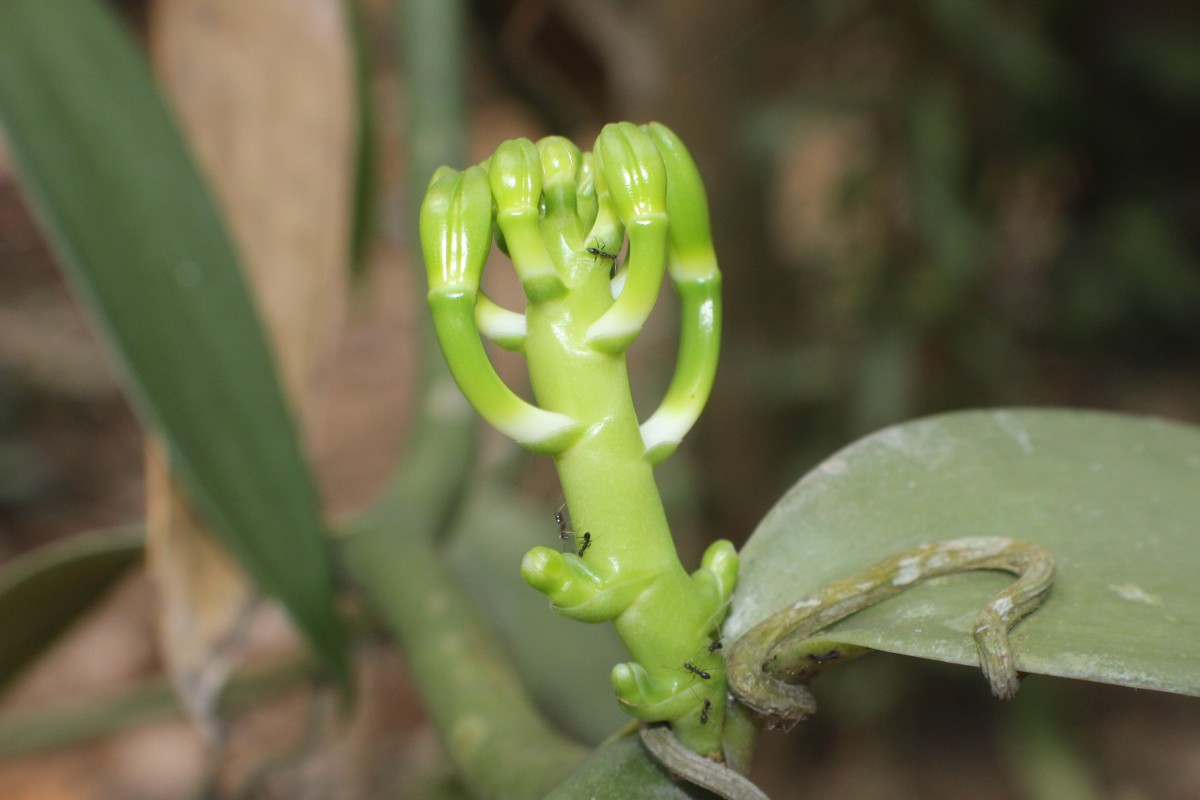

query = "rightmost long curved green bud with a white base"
(641, 122), (721, 464)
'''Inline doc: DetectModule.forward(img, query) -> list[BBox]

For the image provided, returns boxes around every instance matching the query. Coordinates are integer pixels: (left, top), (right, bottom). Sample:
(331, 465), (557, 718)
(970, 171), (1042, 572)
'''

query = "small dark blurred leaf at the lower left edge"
(0, 527), (143, 690)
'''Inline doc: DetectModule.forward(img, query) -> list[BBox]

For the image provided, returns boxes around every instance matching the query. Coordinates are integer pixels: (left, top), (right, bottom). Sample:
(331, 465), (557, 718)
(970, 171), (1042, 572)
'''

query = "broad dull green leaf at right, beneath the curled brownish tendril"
(726, 410), (1200, 694)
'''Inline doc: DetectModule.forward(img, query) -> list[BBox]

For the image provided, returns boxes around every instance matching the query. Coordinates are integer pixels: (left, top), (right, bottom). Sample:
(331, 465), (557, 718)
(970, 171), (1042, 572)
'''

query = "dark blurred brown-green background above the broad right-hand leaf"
(439, 0), (1200, 536)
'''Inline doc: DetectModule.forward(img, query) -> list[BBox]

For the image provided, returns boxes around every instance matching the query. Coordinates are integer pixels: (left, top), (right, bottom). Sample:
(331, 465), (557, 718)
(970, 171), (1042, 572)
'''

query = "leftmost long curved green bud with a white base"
(420, 167), (582, 453)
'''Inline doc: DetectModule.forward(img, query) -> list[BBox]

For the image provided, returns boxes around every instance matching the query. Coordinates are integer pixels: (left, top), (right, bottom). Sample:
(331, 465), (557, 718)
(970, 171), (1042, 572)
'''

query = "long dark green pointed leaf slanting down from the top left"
(0, 0), (347, 678)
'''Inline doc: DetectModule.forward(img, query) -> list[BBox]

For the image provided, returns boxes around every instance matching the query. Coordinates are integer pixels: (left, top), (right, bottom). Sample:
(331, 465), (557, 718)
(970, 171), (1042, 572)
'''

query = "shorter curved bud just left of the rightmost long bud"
(587, 122), (667, 353)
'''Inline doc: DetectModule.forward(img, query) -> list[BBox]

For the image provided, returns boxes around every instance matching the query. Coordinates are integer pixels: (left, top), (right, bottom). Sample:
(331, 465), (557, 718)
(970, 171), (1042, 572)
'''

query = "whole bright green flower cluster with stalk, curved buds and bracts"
(421, 122), (738, 754)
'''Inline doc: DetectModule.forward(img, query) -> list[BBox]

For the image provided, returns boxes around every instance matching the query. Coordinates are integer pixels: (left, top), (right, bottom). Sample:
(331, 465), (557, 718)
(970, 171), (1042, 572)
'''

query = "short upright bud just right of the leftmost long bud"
(487, 139), (566, 302)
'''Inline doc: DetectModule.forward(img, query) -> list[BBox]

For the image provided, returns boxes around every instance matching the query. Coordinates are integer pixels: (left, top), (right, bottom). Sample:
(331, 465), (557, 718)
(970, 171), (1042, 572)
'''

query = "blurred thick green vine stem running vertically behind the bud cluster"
(350, 0), (584, 800)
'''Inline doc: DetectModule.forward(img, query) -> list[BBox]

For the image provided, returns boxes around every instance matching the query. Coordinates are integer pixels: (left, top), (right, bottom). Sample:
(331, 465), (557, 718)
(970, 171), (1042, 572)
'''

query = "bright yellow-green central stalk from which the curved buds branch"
(526, 266), (725, 752)
